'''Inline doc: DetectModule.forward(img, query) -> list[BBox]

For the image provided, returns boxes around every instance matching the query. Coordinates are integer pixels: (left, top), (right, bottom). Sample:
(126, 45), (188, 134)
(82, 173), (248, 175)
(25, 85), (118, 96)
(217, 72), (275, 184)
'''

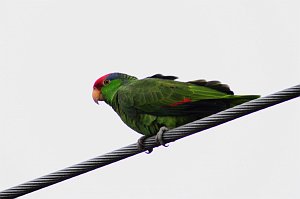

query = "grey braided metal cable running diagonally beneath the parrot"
(0, 84), (300, 198)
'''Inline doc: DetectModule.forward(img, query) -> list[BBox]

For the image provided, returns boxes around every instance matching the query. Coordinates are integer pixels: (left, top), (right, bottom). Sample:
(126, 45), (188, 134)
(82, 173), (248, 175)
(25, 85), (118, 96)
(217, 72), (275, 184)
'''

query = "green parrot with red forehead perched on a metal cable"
(92, 72), (260, 153)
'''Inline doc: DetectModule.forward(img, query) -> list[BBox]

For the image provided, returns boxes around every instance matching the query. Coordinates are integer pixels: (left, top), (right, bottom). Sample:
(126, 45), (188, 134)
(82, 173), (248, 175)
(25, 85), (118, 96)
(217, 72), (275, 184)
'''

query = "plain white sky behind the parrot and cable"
(0, 0), (300, 199)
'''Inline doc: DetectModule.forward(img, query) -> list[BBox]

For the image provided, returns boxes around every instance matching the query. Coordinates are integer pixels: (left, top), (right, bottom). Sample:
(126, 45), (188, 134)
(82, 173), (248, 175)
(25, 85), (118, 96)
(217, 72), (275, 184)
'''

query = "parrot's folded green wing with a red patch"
(117, 78), (233, 116)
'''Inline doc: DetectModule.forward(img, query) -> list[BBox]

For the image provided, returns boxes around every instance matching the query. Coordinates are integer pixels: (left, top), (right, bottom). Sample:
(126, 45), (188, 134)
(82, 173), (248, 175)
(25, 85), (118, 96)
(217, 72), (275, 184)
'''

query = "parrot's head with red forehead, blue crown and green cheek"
(92, 73), (136, 104)
